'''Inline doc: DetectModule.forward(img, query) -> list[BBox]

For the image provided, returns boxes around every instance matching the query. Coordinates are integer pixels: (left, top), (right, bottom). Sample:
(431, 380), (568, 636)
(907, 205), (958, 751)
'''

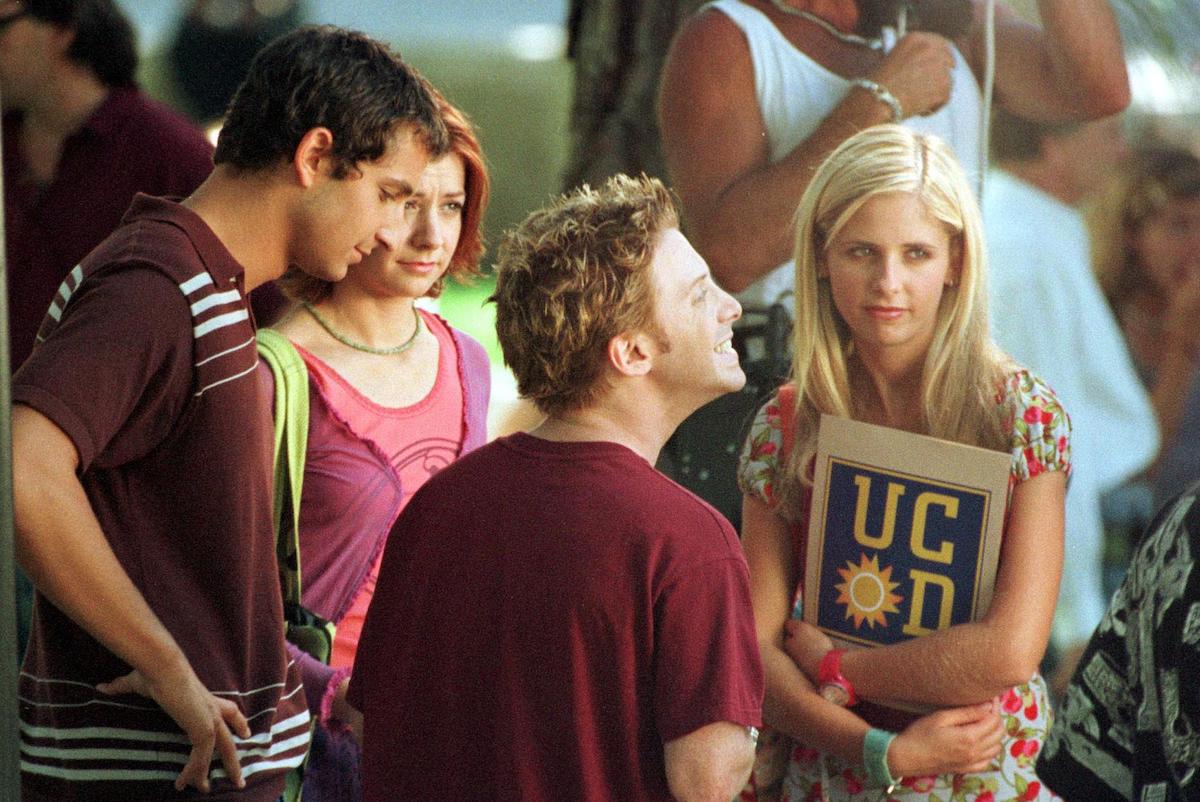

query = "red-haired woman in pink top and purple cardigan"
(267, 101), (491, 802)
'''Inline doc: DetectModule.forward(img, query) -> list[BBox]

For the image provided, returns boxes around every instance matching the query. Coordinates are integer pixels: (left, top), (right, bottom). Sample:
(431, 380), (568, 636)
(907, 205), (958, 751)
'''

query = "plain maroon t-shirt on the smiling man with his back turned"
(350, 435), (763, 802)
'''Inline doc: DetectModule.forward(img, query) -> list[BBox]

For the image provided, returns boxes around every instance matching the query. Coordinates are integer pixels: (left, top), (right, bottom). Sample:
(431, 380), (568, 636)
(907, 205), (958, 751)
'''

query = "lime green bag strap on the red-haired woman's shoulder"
(258, 329), (308, 605)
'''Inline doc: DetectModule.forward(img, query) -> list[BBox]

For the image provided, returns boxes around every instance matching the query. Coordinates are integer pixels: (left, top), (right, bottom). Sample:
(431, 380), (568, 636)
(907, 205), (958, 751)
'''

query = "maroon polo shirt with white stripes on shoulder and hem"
(13, 196), (310, 802)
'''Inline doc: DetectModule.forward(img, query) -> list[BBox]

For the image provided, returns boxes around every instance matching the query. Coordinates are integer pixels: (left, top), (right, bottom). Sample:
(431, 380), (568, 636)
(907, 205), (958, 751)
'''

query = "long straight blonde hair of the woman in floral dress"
(776, 125), (1012, 517)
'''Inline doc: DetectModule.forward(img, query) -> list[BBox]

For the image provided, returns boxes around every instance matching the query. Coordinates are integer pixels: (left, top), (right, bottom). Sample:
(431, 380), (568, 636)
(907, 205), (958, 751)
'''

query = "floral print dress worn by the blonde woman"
(738, 370), (1070, 802)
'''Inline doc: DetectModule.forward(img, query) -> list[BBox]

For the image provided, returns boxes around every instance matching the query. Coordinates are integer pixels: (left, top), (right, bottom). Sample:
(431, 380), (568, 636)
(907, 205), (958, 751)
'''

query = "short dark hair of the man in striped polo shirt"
(212, 25), (450, 178)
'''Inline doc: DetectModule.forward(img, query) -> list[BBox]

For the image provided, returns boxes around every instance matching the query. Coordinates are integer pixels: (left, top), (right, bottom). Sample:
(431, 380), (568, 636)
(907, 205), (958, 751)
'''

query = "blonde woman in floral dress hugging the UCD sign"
(739, 125), (1069, 802)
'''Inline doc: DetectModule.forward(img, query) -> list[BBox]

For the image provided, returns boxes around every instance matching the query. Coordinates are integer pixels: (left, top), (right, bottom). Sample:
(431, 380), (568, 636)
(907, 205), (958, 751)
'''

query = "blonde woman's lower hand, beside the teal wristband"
(888, 701), (1004, 777)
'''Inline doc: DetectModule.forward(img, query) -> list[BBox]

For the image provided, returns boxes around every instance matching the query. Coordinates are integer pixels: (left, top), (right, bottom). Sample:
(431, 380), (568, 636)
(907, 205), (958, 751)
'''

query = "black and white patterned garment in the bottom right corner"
(1038, 485), (1200, 802)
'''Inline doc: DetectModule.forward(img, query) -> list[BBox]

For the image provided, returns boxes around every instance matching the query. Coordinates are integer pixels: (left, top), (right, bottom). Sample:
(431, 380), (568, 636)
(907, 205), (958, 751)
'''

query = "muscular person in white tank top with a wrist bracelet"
(659, 0), (1129, 309)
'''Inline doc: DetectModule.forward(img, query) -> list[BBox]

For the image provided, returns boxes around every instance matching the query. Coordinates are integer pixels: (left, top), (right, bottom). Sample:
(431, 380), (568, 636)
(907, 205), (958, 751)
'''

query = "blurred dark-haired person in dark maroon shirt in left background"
(0, 0), (212, 369)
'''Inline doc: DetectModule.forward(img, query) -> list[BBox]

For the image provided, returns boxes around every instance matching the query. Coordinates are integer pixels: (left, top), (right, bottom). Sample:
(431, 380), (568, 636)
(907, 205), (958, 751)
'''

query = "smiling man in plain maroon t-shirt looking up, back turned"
(348, 175), (763, 802)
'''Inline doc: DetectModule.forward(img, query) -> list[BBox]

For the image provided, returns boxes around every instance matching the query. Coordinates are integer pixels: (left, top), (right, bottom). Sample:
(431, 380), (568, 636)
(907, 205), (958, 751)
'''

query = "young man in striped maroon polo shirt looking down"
(13, 28), (446, 802)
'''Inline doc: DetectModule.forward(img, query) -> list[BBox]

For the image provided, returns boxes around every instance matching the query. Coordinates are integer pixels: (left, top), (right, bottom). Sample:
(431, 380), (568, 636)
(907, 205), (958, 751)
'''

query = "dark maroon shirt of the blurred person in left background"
(4, 88), (212, 370)
